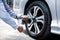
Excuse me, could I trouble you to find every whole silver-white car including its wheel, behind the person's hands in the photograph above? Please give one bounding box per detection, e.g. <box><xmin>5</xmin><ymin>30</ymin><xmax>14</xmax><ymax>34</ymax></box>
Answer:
<box><xmin>8</xmin><ymin>0</ymin><xmax>60</xmax><ymax>39</ymax></box>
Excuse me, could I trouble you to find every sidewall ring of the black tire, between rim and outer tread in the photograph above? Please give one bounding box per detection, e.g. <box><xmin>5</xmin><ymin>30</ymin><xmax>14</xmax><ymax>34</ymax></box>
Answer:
<box><xmin>26</xmin><ymin>1</ymin><xmax>50</xmax><ymax>39</ymax></box>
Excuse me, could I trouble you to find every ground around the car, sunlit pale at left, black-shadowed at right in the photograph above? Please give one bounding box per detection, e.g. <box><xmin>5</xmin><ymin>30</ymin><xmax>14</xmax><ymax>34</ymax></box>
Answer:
<box><xmin>0</xmin><ymin>20</ymin><xmax>60</xmax><ymax>40</ymax></box>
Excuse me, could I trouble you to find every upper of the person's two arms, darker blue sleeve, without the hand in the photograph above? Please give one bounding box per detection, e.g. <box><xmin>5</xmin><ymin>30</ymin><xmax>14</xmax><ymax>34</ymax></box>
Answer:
<box><xmin>2</xmin><ymin>0</ymin><xmax>20</xmax><ymax>19</ymax></box>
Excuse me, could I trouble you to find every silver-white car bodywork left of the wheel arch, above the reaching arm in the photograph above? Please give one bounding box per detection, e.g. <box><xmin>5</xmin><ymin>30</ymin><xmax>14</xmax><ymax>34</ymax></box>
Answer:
<box><xmin>13</xmin><ymin>0</ymin><xmax>28</xmax><ymax>15</ymax></box>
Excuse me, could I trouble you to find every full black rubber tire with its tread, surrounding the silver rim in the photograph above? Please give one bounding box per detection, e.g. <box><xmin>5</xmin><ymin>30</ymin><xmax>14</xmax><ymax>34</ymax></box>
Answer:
<box><xmin>25</xmin><ymin>1</ymin><xmax>51</xmax><ymax>39</ymax></box>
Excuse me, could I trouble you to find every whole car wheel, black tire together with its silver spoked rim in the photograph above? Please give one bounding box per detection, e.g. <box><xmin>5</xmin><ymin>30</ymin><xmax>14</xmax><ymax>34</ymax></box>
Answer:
<box><xmin>25</xmin><ymin>1</ymin><xmax>51</xmax><ymax>39</ymax></box>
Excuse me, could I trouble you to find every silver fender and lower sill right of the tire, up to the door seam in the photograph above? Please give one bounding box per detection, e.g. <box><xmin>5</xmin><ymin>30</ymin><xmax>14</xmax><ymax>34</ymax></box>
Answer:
<box><xmin>46</xmin><ymin>0</ymin><xmax>60</xmax><ymax>34</ymax></box>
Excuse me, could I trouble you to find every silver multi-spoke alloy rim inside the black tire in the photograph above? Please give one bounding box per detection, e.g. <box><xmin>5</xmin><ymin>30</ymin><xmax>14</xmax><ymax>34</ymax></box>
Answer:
<box><xmin>27</xmin><ymin>6</ymin><xmax>44</xmax><ymax>35</ymax></box>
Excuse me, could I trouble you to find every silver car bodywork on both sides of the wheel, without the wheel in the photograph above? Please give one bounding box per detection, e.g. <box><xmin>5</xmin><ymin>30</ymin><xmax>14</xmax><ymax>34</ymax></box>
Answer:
<box><xmin>13</xmin><ymin>0</ymin><xmax>60</xmax><ymax>34</ymax></box>
